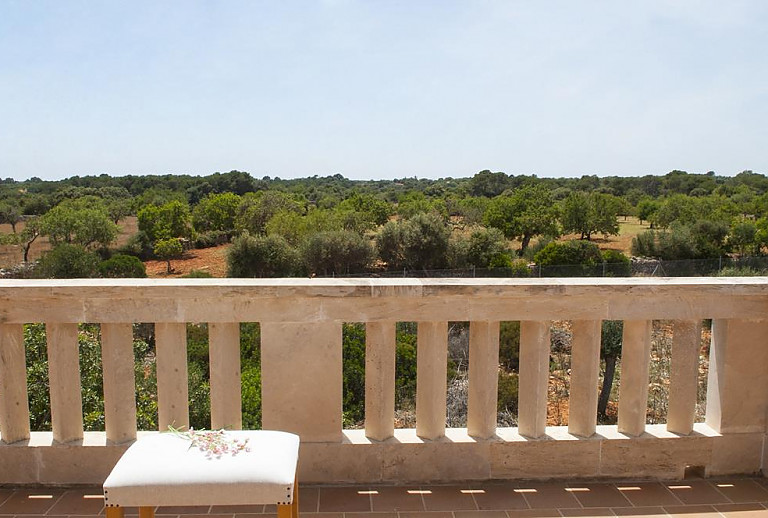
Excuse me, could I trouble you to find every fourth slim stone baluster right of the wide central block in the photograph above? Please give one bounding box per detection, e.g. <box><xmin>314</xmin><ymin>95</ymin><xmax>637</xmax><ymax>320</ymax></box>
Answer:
<box><xmin>517</xmin><ymin>321</ymin><xmax>550</xmax><ymax>438</ymax></box>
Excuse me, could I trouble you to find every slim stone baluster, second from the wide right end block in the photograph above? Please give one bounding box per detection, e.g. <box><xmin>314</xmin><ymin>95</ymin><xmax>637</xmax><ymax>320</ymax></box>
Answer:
<box><xmin>618</xmin><ymin>320</ymin><xmax>652</xmax><ymax>436</ymax></box>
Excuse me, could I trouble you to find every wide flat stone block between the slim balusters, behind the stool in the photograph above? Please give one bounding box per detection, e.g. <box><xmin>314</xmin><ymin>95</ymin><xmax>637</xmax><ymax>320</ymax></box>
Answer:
<box><xmin>261</xmin><ymin>322</ymin><xmax>342</xmax><ymax>442</ymax></box>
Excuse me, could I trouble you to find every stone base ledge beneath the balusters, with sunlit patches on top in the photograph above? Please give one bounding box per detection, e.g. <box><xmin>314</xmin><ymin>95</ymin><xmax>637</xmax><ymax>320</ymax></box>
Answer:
<box><xmin>0</xmin><ymin>423</ymin><xmax>766</xmax><ymax>486</ymax></box>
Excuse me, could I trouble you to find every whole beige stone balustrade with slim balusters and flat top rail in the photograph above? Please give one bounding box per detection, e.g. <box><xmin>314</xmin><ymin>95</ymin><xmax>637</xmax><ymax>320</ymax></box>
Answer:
<box><xmin>0</xmin><ymin>278</ymin><xmax>768</xmax><ymax>484</ymax></box>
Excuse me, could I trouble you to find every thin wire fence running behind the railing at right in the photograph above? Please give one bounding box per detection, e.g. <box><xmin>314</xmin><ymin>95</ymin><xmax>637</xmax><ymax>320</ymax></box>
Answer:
<box><xmin>324</xmin><ymin>256</ymin><xmax>768</xmax><ymax>278</ymax></box>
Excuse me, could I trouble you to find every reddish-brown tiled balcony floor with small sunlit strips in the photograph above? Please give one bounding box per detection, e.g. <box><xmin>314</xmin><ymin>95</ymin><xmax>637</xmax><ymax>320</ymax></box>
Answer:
<box><xmin>0</xmin><ymin>478</ymin><xmax>768</xmax><ymax>518</ymax></box>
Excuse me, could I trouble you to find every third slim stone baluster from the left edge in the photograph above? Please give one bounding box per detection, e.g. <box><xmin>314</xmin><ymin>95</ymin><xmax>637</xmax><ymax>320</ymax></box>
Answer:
<box><xmin>101</xmin><ymin>324</ymin><xmax>136</xmax><ymax>444</ymax></box>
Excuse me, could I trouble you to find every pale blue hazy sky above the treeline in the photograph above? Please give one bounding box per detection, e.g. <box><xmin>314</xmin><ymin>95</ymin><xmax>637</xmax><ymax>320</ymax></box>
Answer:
<box><xmin>0</xmin><ymin>0</ymin><xmax>768</xmax><ymax>180</ymax></box>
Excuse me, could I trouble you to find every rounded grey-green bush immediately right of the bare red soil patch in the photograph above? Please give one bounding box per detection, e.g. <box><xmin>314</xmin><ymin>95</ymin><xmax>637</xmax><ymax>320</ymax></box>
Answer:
<box><xmin>227</xmin><ymin>233</ymin><xmax>299</xmax><ymax>277</ymax></box>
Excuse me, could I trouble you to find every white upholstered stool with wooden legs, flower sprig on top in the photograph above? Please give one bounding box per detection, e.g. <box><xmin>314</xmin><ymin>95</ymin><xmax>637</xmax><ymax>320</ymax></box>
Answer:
<box><xmin>104</xmin><ymin>430</ymin><xmax>299</xmax><ymax>518</ymax></box>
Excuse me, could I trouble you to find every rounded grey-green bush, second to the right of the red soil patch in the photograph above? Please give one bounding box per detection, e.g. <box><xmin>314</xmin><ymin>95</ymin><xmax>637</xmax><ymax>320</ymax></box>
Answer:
<box><xmin>301</xmin><ymin>230</ymin><xmax>373</xmax><ymax>275</ymax></box>
